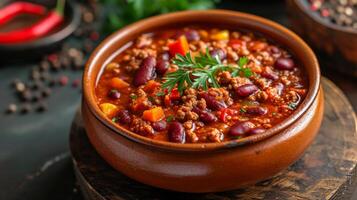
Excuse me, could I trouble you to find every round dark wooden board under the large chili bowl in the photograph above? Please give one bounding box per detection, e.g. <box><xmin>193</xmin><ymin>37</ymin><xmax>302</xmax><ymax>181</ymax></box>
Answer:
<box><xmin>70</xmin><ymin>79</ymin><xmax>357</xmax><ymax>200</ymax></box>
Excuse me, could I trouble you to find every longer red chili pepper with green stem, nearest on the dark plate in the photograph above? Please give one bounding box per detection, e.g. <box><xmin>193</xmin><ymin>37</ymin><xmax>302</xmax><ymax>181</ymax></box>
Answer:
<box><xmin>0</xmin><ymin>0</ymin><xmax>64</xmax><ymax>44</ymax></box>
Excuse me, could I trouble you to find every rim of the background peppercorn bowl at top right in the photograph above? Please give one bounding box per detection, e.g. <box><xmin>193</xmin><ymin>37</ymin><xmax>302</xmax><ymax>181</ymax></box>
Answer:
<box><xmin>290</xmin><ymin>0</ymin><xmax>357</xmax><ymax>34</ymax></box>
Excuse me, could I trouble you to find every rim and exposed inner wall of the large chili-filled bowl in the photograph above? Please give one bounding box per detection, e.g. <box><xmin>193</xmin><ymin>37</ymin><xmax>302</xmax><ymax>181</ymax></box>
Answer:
<box><xmin>83</xmin><ymin>10</ymin><xmax>320</xmax><ymax>151</ymax></box>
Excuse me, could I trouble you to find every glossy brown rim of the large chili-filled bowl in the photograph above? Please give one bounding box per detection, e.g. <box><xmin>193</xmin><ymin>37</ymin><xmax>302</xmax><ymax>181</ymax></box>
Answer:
<box><xmin>82</xmin><ymin>10</ymin><xmax>320</xmax><ymax>151</ymax></box>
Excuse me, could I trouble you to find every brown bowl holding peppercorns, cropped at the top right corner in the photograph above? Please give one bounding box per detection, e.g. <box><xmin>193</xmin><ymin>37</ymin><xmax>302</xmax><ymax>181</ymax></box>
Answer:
<box><xmin>286</xmin><ymin>0</ymin><xmax>357</xmax><ymax>77</ymax></box>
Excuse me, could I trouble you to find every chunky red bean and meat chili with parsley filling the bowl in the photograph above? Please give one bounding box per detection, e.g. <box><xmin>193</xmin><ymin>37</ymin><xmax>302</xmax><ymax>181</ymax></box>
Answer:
<box><xmin>95</xmin><ymin>26</ymin><xmax>308</xmax><ymax>143</ymax></box>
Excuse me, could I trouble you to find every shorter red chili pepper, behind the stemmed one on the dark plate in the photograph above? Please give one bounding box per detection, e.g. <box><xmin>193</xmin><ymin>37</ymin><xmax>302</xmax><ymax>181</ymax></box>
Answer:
<box><xmin>0</xmin><ymin>1</ymin><xmax>47</xmax><ymax>25</ymax></box>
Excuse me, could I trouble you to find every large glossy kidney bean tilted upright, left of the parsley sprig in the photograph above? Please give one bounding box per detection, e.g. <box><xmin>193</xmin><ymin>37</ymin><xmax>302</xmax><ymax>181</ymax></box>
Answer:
<box><xmin>133</xmin><ymin>56</ymin><xmax>156</xmax><ymax>87</ymax></box>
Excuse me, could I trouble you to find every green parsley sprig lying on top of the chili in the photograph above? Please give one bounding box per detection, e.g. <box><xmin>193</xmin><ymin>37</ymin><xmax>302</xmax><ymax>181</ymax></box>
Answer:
<box><xmin>162</xmin><ymin>49</ymin><xmax>253</xmax><ymax>95</ymax></box>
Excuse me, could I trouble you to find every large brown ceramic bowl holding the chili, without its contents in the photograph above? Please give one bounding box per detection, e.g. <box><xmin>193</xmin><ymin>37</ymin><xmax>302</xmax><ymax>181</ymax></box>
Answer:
<box><xmin>82</xmin><ymin>10</ymin><xmax>323</xmax><ymax>192</ymax></box>
